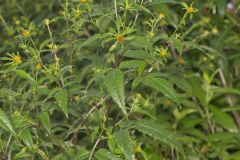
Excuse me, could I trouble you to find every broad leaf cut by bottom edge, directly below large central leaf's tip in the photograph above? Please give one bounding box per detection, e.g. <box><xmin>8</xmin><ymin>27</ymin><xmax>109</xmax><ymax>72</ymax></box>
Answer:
<box><xmin>114</xmin><ymin>130</ymin><xmax>135</xmax><ymax>160</ymax></box>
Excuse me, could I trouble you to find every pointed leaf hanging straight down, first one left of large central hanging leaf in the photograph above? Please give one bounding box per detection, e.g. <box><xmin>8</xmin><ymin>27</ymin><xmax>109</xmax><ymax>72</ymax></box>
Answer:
<box><xmin>55</xmin><ymin>89</ymin><xmax>68</xmax><ymax>117</ymax></box>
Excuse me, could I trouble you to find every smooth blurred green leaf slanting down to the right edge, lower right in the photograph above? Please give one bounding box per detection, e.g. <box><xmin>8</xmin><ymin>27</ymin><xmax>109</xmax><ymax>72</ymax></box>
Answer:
<box><xmin>210</xmin><ymin>106</ymin><xmax>238</xmax><ymax>132</ymax></box>
